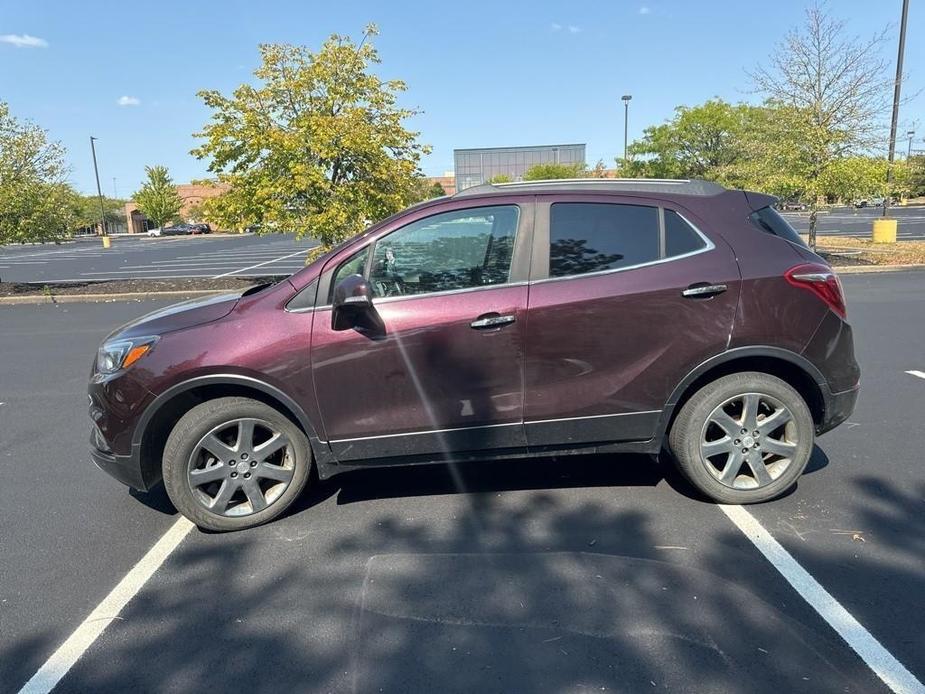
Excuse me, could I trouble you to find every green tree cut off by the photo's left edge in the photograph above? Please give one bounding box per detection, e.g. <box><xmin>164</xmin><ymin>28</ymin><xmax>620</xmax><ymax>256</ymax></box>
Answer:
<box><xmin>0</xmin><ymin>101</ymin><xmax>77</xmax><ymax>245</ymax></box>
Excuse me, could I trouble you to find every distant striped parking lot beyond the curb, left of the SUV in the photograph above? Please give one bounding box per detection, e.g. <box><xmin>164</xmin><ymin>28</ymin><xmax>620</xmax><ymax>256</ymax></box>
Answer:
<box><xmin>0</xmin><ymin>234</ymin><xmax>315</xmax><ymax>283</ymax></box>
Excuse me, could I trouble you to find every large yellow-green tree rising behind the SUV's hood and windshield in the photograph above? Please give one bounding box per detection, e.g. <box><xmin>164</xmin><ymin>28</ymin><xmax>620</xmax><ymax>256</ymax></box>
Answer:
<box><xmin>193</xmin><ymin>24</ymin><xmax>430</xmax><ymax>246</ymax></box>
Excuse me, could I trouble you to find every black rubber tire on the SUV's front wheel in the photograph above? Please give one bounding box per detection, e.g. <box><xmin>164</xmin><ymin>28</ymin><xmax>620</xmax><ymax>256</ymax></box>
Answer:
<box><xmin>162</xmin><ymin>397</ymin><xmax>312</xmax><ymax>532</ymax></box>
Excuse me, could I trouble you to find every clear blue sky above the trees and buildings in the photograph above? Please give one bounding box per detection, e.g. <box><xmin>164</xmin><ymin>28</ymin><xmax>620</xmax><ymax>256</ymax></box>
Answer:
<box><xmin>0</xmin><ymin>0</ymin><xmax>925</xmax><ymax>197</ymax></box>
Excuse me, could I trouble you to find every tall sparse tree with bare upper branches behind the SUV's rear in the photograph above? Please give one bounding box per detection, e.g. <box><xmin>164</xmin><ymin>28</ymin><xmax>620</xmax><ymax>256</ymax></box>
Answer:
<box><xmin>752</xmin><ymin>5</ymin><xmax>892</xmax><ymax>247</ymax></box>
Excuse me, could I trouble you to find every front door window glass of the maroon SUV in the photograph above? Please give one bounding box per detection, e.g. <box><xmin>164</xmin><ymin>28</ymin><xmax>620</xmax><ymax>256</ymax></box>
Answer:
<box><xmin>369</xmin><ymin>205</ymin><xmax>518</xmax><ymax>296</ymax></box>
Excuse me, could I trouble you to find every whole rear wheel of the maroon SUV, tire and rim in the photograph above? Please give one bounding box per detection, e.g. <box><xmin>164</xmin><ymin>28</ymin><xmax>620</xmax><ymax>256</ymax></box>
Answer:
<box><xmin>668</xmin><ymin>372</ymin><xmax>814</xmax><ymax>504</ymax></box>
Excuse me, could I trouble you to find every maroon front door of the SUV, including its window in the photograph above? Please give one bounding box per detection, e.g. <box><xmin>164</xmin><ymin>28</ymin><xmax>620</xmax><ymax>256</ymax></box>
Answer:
<box><xmin>312</xmin><ymin>202</ymin><xmax>533</xmax><ymax>461</ymax></box>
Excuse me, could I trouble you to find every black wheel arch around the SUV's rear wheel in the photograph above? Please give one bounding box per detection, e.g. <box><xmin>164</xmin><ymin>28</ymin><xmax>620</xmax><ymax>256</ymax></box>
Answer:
<box><xmin>656</xmin><ymin>347</ymin><xmax>828</xmax><ymax>441</ymax></box>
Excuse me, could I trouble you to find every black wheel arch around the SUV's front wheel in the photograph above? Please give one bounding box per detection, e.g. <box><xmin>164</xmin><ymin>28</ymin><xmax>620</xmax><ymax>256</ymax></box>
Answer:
<box><xmin>132</xmin><ymin>374</ymin><xmax>331</xmax><ymax>489</ymax></box>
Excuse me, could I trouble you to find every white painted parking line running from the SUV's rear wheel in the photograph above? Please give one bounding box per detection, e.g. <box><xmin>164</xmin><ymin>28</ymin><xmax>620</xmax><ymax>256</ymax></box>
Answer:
<box><xmin>719</xmin><ymin>504</ymin><xmax>925</xmax><ymax>694</ymax></box>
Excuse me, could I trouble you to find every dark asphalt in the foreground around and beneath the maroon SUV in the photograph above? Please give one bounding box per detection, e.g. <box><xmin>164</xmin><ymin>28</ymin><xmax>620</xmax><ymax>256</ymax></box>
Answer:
<box><xmin>0</xmin><ymin>270</ymin><xmax>925</xmax><ymax>693</ymax></box>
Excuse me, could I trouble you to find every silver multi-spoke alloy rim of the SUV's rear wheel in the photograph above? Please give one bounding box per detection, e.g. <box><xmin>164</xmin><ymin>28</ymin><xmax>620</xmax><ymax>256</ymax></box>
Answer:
<box><xmin>700</xmin><ymin>393</ymin><xmax>799</xmax><ymax>489</ymax></box>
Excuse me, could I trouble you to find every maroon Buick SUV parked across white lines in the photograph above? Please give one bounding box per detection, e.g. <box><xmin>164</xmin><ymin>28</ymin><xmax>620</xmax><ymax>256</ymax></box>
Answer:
<box><xmin>90</xmin><ymin>180</ymin><xmax>859</xmax><ymax>530</ymax></box>
